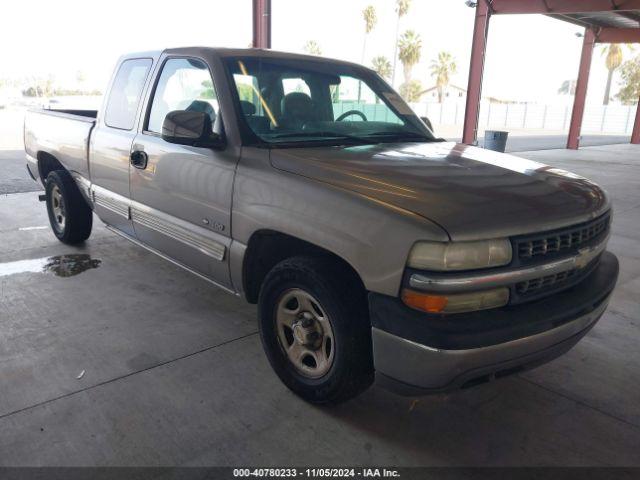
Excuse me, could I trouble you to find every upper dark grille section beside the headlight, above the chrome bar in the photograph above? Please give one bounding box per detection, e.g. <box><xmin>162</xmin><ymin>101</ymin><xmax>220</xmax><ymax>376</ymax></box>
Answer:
<box><xmin>515</xmin><ymin>214</ymin><xmax>610</xmax><ymax>260</ymax></box>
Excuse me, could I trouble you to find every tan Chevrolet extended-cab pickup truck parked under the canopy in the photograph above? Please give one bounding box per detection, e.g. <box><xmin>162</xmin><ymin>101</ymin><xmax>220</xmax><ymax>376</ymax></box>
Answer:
<box><xmin>24</xmin><ymin>48</ymin><xmax>618</xmax><ymax>403</ymax></box>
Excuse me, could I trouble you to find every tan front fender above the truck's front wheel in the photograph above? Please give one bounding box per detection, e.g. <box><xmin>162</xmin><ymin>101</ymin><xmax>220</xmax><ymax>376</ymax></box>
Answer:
<box><xmin>231</xmin><ymin>148</ymin><xmax>449</xmax><ymax>295</ymax></box>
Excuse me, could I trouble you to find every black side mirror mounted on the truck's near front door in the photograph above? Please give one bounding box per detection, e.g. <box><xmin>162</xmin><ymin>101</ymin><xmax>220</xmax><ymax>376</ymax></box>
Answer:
<box><xmin>162</xmin><ymin>110</ymin><xmax>224</xmax><ymax>148</ymax></box>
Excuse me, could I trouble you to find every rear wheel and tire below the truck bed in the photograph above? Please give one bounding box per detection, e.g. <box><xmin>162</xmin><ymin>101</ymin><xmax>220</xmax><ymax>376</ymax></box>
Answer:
<box><xmin>45</xmin><ymin>170</ymin><xmax>93</xmax><ymax>245</ymax></box>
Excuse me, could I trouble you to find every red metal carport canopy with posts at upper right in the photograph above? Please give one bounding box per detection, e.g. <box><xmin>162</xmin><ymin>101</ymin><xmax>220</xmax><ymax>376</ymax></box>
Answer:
<box><xmin>462</xmin><ymin>0</ymin><xmax>640</xmax><ymax>149</ymax></box>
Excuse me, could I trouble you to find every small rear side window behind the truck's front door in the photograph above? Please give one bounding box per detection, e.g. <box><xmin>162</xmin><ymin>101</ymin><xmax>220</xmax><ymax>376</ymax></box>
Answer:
<box><xmin>104</xmin><ymin>58</ymin><xmax>152</xmax><ymax>130</ymax></box>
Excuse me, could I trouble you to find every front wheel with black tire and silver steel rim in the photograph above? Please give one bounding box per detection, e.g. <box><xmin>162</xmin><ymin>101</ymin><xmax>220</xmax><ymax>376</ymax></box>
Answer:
<box><xmin>258</xmin><ymin>257</ymin><xmax>373</xmax><ymax>404</ymax></box>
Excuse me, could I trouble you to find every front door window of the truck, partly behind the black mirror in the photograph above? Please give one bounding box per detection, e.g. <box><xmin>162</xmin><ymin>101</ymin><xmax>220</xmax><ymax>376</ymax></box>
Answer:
<box><xmin>147</xmin><ymin>58</ymin><xmax>218</xmax><ymax>133</ymax></box>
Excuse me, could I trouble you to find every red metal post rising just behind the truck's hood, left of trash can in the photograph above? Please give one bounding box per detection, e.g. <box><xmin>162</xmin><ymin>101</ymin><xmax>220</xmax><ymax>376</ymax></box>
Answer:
<box><xmin>462</xmin><ymin>0</ymin><xmax>491</xmax><ymax>145</ymax></box>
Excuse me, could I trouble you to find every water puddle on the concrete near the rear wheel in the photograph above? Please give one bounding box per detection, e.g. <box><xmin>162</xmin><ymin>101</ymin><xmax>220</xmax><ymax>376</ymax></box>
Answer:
<box><xmin>0</xmin><ymin>253</ymin><xmax>102</xmax><ymax>277</ymax></box>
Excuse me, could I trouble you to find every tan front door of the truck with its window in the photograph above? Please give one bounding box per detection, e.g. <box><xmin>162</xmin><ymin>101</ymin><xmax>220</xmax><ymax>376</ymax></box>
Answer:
<box><xmin>131</xmin><ymin>57</ymin><xmax>237</xmax><ymax>288</ymax></box>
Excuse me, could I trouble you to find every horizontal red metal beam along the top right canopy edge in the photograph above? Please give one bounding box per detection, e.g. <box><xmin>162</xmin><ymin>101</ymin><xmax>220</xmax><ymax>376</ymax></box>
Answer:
<box><xmin>478</xmin><ymin>0</ymin><xmax>640</xmax><ymax>15</ymax></box>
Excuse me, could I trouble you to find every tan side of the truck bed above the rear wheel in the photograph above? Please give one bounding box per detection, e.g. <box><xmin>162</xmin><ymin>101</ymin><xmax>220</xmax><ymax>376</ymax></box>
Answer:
<box><xmin>24</xmin><ymin>109</ymin><xmax>98</xmax><ymax>184</ymax></box>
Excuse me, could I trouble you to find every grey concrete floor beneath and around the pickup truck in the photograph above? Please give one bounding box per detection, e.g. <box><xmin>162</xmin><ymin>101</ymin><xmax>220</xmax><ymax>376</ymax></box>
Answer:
<box><xmin>0</xmin><ymin>145</ymin><xmax>640</xmax><ymax>466</ymax></box>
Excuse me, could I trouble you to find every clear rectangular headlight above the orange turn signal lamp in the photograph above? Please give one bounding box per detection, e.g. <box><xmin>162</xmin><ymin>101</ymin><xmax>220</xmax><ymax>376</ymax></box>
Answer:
<box><xmin>407</xmin><ymin>238</ymin><xmax>511</xmax><ymax>271</ymax></box>
